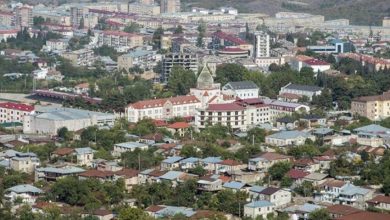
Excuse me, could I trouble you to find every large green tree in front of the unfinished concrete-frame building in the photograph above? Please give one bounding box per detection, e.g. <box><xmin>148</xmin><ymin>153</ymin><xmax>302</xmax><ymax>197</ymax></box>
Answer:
<box><xmin>167</xmin><ymin>66</ymin><xmax>196</xmax><ymax>95</ymax></box>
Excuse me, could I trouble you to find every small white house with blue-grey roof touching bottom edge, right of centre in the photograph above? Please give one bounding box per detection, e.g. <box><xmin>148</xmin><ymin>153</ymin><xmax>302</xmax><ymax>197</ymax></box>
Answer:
<box><xmin>244</xmin><ymin>200</ymin><xmax>275</xmax><ymax>219</ymax></box>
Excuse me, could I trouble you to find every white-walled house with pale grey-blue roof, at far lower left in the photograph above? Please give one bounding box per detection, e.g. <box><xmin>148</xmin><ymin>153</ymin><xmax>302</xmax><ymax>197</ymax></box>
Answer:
<box><xmin>4</xmin><ymin>184</ymin><xmax>43</xmax><ymax>205</ymax></box>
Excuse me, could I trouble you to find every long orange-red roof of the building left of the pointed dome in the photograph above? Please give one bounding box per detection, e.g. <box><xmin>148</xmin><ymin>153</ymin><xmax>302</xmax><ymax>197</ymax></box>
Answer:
<box><xmin>128</xmin><ymin>95</ymin><xmax>200</xmax><ymax>109</ymax></box>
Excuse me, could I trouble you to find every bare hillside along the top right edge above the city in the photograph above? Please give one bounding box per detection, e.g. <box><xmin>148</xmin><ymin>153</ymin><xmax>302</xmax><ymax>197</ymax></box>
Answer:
<box><xmin>182</xmin><ymin>0</ymin><xmax>390</xmax><ymax>25</ymax></box>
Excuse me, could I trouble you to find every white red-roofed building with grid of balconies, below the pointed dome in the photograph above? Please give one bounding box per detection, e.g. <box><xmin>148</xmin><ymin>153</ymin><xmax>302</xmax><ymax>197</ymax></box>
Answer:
<box><xmin>195</xmin><ymin>103</ymin><xmax>247</xmax><ymax>131</ymax></box>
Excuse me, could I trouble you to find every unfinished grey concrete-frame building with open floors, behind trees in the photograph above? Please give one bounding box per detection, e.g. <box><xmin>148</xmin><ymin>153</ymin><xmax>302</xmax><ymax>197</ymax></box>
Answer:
<box><xmin>160</xmin><ymin>53</ymin><xmax>198</xmax><ymax>82</ymax></box>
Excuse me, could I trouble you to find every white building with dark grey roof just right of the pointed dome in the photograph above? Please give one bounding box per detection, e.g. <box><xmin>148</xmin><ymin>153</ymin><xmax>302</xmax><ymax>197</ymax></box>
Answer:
<box><xmin>222</xmin><ymin>81</ymin><xmax>260</xmax><ymax>99</ymax></box>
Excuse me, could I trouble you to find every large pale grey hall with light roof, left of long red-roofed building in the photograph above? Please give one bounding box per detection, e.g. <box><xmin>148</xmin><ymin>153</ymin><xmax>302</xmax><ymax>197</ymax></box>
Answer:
<box><xmin>23</xmin><ymin>107</ymin><xmax>115</xmax><ymax>135</ymax></box>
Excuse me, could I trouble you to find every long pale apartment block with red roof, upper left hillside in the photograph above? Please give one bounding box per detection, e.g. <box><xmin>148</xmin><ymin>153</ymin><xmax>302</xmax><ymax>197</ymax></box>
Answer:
<box><xmin>97</xmin><ymin>31</ymin><xmax>144</xmax><ymax>49</ymax></box>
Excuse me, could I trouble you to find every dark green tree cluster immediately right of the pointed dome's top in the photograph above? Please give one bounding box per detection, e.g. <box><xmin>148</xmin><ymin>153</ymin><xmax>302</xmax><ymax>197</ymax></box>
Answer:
<box><xmin>215</xmin><ymin>63</ymin><xmax>248</xmax><ymax>85</ymax></box>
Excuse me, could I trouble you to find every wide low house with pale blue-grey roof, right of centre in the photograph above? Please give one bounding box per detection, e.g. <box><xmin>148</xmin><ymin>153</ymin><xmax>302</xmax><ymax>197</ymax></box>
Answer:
<box><xmin>265</xmin><ymin>131</ymin><xmax>315</xmax><ymax>147</ymax></box>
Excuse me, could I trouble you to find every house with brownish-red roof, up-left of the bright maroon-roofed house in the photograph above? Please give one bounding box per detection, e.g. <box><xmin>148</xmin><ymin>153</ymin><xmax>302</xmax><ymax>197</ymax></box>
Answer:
<box><xmin>248</xmin><ymin>152</ymin><xmax>292</xmax><ymax>172</ymax></box>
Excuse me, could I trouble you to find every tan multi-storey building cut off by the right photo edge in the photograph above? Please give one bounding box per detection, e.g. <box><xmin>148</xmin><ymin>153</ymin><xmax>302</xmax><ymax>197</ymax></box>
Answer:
<box><xmin>351</xmin><ymin>91</ymin><xmax>390</xmax><ymax>120</ymax></box>
